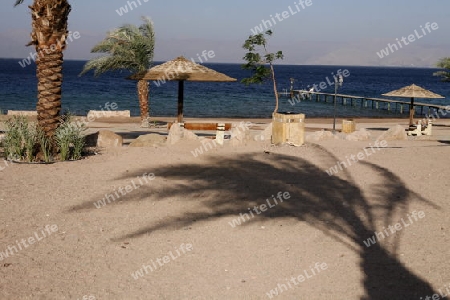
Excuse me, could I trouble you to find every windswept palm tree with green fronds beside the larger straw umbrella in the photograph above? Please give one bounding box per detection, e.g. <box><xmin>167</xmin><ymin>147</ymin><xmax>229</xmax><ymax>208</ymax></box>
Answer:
<box><xmin>80</xmin><ymin>17</ymin><xmax>155</xmax><ymax>127</ymax></box>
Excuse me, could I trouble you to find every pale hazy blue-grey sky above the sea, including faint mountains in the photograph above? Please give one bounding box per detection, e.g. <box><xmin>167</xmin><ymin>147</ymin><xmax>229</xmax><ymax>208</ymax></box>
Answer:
<box><xmin>0</xmin><ymin>0</ymin><xmax>450</xmax><ymax>66</ymax></box>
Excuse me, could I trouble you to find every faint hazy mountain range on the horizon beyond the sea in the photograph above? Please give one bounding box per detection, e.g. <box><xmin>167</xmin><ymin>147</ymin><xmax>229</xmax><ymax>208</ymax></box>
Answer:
<box><xmin>0</xmin><ymin>30</ymin><xmax>450</xmax><ymax>67</ymax></box>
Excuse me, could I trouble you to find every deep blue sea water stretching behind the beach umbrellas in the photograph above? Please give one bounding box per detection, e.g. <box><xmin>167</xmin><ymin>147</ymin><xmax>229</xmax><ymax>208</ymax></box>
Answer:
<box><xmin>0</xmin><ymin>59</ymin><xmax>450</xmax><ymax>118</ymax></box>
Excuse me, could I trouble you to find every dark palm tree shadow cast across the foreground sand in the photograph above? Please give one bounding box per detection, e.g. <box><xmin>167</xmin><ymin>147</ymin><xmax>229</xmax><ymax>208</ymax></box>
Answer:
<box><xmin>74</xmin><ymin>147</ymin><xmax>438</xmax><ymax>300</ymax></box>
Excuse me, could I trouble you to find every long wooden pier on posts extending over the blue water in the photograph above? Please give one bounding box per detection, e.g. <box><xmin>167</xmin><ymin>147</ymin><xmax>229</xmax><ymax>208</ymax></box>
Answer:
<box><xmin>280</xmin><ymin>90</ymin><xmax>446</xmax><ymax>116</ymax></box>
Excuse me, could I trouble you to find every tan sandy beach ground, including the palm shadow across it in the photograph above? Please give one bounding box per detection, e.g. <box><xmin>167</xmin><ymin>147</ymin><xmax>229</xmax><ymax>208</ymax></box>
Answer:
<box><xmin>0</xmin><ymin>118</ymin><xmax>450</xmax><ymax>300</ymax></box>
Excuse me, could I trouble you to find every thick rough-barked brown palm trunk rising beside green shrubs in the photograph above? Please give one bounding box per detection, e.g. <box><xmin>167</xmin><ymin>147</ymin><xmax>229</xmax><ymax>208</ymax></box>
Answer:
<box><xmin>15</xmin><ymin>0</ymin><xmax>71</xmax><ymax>144</ymax></box>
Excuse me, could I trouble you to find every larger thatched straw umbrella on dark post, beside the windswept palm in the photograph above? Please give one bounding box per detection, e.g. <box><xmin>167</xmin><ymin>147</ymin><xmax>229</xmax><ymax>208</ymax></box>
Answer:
<box><xmin>129</xmin><ymin>56</ymin><xmax>237</xmax><ymax>123</ymax></box>
